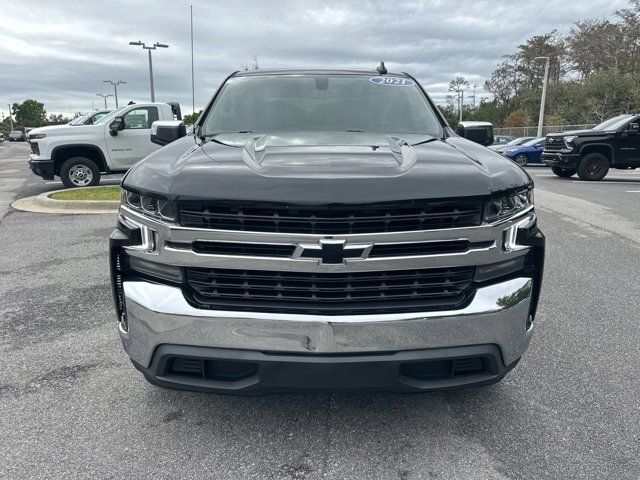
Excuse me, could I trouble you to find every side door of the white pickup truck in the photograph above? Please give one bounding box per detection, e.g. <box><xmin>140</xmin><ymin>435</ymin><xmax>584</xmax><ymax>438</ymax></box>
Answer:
<box><xmin>106</xmin><ymin>107</ymin><xmax>160</xmax><ymax>170</ymax></box>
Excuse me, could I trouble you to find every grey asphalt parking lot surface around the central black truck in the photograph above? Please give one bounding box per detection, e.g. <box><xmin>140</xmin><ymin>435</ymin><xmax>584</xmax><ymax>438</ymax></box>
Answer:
<box><xmin>0</xmin><ymin>143</ymin><xmax>640</xmax><ymax>479</ymax></box>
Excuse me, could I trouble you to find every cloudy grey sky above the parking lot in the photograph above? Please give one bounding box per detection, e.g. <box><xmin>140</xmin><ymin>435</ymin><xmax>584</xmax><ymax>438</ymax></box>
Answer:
<box><xmin>0</xmin><ymin>0</ymin><xmax>627</xmax><ymax>115</ymax></box>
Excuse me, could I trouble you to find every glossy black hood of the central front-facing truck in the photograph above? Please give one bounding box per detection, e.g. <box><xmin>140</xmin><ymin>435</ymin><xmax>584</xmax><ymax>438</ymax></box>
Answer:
<box><xmin>124</xmin><ymin>132</ymin><xmax>532</xmax><ymax>204</ymax></box>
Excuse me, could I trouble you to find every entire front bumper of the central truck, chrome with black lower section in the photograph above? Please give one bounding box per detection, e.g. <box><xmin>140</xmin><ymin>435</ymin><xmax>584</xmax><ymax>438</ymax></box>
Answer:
<box><xmin>120</xmin><ymin>277</ymin><xmax>533</xmax><ymax>394</ymax></box>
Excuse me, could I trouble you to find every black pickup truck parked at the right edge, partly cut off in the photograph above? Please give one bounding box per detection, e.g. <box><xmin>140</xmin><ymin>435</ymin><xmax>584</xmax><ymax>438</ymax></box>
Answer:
<box><xmin>542</xmin><ymin>114</ymin><xmax>640</xmax><ymax>180</ymax></box>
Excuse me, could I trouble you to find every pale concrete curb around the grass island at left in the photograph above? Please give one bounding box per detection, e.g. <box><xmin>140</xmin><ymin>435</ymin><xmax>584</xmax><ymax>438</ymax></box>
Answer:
<box><xmin>11</xmin><ymin>187</ymin><xmax>120</xmax><ymax>214</ymax></box>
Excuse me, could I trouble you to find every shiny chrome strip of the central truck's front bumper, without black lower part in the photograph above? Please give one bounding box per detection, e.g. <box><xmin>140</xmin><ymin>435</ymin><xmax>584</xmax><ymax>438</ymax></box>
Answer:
<box><xmin>120</xmin><ymin>278</ymin><xmax>533</xmax><ymax>367</ymax></box>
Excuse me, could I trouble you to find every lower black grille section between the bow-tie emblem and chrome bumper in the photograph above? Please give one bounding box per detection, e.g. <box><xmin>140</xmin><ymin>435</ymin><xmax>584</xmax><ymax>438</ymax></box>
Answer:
<box><xmin>186</xmin><ymin>267</ymin><xmax>474</xmax><ymax>315</ymax></box>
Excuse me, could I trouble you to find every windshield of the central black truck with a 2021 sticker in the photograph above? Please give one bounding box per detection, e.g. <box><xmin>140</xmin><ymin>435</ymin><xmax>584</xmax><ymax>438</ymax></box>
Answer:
<box><xmin>202</xmin><ymin>74</ymin><xmax>441</xmax><ymax>138</ymax></box>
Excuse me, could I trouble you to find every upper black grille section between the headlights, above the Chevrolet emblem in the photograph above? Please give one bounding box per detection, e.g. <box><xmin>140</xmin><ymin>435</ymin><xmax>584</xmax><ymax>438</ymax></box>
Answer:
<box><xmin>179</xmin><ymin>200</ymin><xmax>483</xmax><ymax>234</ymax></box>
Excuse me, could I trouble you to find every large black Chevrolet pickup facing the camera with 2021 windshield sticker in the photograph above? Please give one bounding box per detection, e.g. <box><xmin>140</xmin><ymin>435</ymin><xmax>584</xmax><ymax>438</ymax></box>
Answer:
<box><xmin>110</xmin><ymin>66</ymin><xmax>544</xmax><ymax>395</ymax></box>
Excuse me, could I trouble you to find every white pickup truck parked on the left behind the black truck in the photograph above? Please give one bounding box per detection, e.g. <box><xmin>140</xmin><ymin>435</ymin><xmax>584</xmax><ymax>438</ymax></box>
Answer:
<box><xmin>28</xmin><ymin>102</ymin><xmax>181</xmax><ymax>188</ymax></box>
